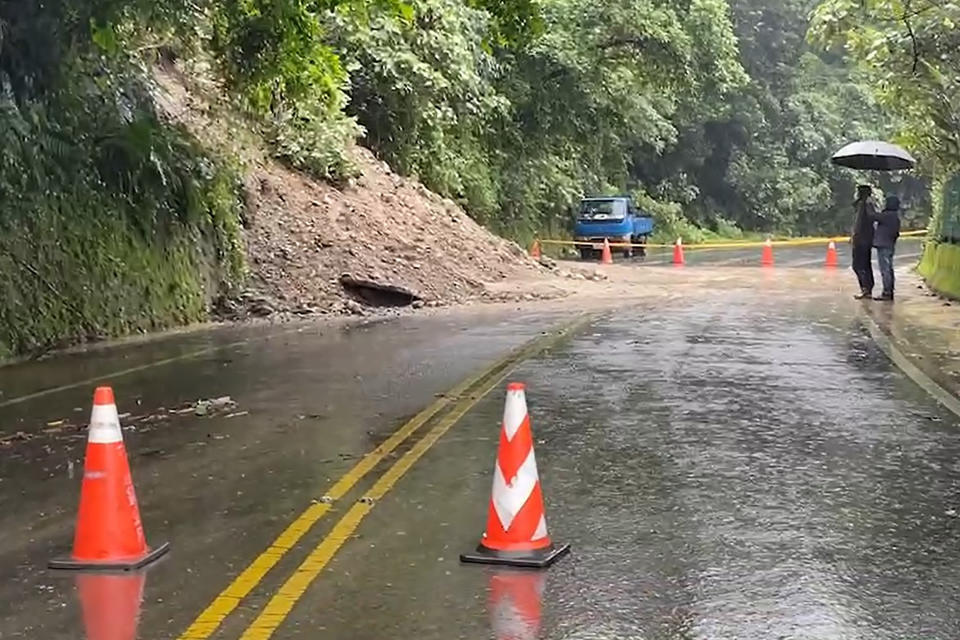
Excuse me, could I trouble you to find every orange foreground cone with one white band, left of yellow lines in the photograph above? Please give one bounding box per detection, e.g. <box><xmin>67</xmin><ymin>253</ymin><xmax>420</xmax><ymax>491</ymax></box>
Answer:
<box><xmin>49</xmin><ymin>387</ymin><xmax>170</xmax><ymax>571</ymax></box>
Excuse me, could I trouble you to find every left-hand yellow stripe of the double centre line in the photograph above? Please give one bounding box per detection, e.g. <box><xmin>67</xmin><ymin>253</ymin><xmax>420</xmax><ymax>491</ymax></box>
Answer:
<box><xmin>178</xmin><ymin>317</ymin><xmax>586</xmax><ymax>640</ymax></box>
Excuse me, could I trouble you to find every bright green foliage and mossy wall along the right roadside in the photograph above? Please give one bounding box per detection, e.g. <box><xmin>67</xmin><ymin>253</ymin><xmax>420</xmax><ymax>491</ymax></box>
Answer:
<box><xmin>810</xmin><ymin>0</ymin><xmax>960</xmax><ymax>297</ymax></box>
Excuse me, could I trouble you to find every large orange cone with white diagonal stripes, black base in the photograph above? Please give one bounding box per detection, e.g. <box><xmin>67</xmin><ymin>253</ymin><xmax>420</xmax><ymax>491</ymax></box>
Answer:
<box><xmin>460</xmin><ymin>383</ymin><xmax>570</xmax><ymax>568</ymax></box>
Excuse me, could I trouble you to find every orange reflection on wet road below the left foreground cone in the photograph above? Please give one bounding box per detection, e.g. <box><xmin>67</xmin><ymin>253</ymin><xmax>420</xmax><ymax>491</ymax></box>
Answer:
<box><xmin>77</xmin><ymin>572</ymin><xmax>146</xmax><ymax>640</ymax></box>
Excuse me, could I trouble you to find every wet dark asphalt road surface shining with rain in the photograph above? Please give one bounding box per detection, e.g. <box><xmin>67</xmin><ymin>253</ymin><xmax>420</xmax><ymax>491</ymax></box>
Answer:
<box><xmin>0</xmin><ymin>240</ymin><xmax>960</xmax><ymax>640</ymax></box>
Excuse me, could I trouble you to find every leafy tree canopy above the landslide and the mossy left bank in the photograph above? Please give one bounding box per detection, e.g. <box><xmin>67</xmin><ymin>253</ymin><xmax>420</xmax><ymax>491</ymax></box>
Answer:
<box><xmin>0</xmin><ymin>0</ymin><xmax>940</xmax><ymax>244</ymax></box>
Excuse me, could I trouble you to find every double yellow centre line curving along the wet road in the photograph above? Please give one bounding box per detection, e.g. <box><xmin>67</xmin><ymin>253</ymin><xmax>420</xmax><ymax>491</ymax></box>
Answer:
<box><xmin>178</xmin><ymin>315</ymin><xmax>589</xmax><ymax>640</ymax></box>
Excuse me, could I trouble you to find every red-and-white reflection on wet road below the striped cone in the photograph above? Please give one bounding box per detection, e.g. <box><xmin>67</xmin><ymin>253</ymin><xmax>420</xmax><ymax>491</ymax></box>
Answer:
<box><xmin>488</xmin><ymin>569</ymin><xmax>546</xmax><ymax>640</ymax></box>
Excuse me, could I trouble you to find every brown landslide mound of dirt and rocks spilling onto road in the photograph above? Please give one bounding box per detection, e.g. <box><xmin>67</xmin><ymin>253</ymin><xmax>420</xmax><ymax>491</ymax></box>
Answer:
<box><xmin>154</xmin><ymin>65</ymin><xmax>561</xmax><ymax>318</ymax></box>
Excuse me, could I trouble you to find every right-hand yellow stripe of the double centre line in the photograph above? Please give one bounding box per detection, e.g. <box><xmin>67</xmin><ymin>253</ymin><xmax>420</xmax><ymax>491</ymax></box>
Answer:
<box><xmin>240</xmin><ymin>360</ymin><xmax>510</xmax><ymax>640</ymax></box>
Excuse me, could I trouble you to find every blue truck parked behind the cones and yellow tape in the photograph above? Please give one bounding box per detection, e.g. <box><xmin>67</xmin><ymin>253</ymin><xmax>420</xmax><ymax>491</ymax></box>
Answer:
<box><xmin>573</xmin><ymin>196</ymin><xmax>653</xmax><ymax>260</ymax></box>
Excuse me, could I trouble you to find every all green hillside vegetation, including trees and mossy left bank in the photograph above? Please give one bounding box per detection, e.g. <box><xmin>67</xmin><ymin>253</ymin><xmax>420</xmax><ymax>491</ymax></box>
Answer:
<box><xmin>0</xmin><ymin>0</ymin><xmax>960</xmax><ymax>357</ymax></box>
